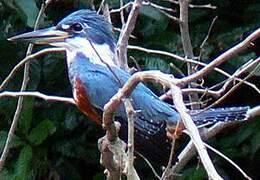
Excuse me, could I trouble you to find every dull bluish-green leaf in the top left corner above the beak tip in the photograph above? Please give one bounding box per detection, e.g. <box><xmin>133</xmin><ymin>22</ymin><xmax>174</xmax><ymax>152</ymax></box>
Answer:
<box><xmin>15</xmin><ymin>0</ymin><xmax>39</xmax><ymax>27</ymax></box>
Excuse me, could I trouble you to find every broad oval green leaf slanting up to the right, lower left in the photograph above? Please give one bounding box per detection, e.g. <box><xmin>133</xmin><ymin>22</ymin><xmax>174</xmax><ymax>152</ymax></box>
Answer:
<box><xmin>28</xmin><ymin>119</ymin><xmax>56</xmax><ymax>145</ymax></box>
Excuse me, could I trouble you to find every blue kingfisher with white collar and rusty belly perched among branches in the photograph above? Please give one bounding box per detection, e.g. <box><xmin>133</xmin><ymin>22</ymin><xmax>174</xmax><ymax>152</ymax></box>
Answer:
<box><xmin>9</xmin><ymin>10</ymin><xmax>253</xmax><ymax>164</ymax></box>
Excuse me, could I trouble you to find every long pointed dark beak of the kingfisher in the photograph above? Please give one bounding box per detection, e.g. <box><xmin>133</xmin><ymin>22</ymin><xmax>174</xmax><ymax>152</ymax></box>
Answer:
<box><xmin>8</xmin><ymin>27</ymin><xmax>70</xmax><ymax>44</ymax></box>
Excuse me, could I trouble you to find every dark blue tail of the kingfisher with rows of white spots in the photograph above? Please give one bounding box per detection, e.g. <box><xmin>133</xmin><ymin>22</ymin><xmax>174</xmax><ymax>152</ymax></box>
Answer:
<box><xmin>190</xmin><ymin>106</ymin><xmax>250</xmax><ymax>125</ymax></box>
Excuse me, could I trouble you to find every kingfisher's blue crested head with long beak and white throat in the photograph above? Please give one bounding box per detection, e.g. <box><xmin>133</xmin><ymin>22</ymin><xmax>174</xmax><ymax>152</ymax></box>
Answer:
<box><xmin>8</xmin><ymin>10</ymin><xmax>115</xmax><ymax>65</ymax></box>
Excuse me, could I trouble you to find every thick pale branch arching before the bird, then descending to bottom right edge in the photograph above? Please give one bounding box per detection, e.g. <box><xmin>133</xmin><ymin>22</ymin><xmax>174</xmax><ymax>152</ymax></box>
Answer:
<box><xmin>103</xmin><ymin>71</ymin><xmax>222</xmax><ymax>179</ymax></box>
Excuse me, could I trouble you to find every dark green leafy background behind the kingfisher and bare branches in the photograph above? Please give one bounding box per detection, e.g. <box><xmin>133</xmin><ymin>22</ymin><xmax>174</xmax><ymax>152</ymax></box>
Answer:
<box><xmin>0</xmin><ymin>0</ymin><xmax>260</xmax><ymax>180</ymax></box>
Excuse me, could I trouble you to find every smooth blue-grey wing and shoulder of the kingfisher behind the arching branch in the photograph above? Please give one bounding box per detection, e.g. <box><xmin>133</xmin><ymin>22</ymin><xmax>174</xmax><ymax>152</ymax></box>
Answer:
<box><xmin>75</xmin><ymin>60</ymin><xmax>179</xmax><ymax>124</ymax></box>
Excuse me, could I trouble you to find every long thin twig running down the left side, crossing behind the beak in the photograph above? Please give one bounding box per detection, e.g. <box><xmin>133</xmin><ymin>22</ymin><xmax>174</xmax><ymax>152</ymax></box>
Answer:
<box><xmin>0</xmin><ymin>0</ymin><xmax>51</xmax><ymax>172</ymax></box>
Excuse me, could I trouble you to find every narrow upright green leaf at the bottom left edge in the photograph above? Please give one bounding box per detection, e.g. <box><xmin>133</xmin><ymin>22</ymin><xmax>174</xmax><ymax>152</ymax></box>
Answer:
<box><xmin>14</xmin><ymin>146</ymin><xmax>33</xmax><ymax>180</ymax></box>
